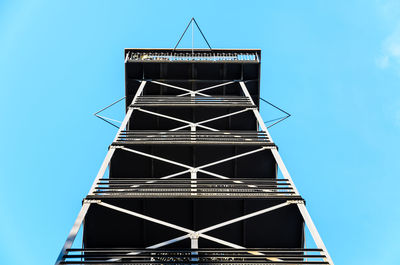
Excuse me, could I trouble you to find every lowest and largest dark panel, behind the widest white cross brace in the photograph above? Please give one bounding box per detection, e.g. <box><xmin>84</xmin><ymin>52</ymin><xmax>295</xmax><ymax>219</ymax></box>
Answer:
<box><xmin>84</xmin><ymin>199</ymin><xmax>303</xmax><ymax>248</ymax></box>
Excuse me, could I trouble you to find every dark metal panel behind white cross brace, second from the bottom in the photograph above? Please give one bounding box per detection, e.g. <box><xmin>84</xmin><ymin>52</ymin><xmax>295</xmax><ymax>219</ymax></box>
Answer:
<box><xmin>110</xmin><ymin>145</ymin><xmax>276</xmax><ymax>178</ymax></box>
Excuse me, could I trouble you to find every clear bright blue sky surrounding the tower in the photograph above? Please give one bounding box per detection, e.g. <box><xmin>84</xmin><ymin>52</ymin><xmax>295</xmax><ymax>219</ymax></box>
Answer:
<box><xmin>0</xmin><ymin>0</ymin><xmax>400</xmax><ymax>265</ymax></box>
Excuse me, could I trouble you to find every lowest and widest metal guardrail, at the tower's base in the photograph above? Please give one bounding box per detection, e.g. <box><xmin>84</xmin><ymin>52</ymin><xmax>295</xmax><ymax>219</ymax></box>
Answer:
<box><xmin>60</xmin><ymin>248</ymin><xmax>329</xmax><ymax>265</ymax></box>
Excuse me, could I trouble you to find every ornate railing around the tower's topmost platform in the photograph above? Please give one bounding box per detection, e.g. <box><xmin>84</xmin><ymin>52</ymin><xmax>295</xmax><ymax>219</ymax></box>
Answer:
<box><xmin>125</xmin><ymin>51</ymin><xmax>259</xmax><ymax>62</ymax></box>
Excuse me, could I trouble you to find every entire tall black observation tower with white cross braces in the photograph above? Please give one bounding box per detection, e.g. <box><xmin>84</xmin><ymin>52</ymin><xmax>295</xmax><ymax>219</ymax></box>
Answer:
<box><xmin>56</xmin><ymin>49</ymin><xmax>333</xmax><ymax>264</ymax></box>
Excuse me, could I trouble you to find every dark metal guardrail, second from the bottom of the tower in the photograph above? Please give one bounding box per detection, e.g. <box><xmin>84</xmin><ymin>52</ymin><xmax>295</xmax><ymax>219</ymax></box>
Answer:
<box><xmin>88</xmin><ymin>178</ymin><xmax>301</xmax><ymax>199</ymax></box>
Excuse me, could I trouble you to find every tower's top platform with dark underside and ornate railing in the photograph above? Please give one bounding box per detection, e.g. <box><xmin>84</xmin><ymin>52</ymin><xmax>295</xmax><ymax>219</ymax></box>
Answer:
<box><xmin>124</xmin><ymin>48</ymin><xmax>261</xmax><ymax>106</ymax></box>
